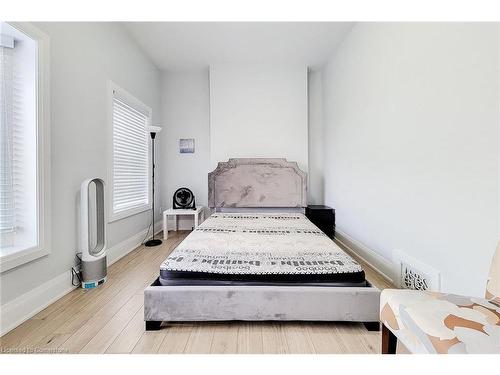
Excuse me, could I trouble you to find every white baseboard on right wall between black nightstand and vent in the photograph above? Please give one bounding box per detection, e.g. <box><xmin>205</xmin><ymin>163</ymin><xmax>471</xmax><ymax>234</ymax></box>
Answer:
<box><xmin>335</xmin><ymin>228</ymin><xmax>394</xmax><ymax>283</ymax></box>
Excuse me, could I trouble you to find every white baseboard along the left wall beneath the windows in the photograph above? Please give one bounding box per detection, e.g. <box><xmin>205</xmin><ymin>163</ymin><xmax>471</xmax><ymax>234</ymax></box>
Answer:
<box><xmin>0</xmin><ymin>221</ymin><xmax>162</xmax><ymax>336</ymax></box>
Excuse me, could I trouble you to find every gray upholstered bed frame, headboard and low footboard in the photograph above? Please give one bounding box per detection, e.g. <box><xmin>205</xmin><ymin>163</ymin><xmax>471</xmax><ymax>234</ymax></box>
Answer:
<box><xmin>144</xmin><ymin>158</ymin><xmax>380</xmax><ymax>330</ymax></box>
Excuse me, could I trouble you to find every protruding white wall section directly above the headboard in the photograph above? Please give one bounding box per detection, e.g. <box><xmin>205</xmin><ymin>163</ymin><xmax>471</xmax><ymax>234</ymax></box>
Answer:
<box><xmin>210</xmin><ymin>64</ymin><xmax>308</xmax><ymax>171</ymax></box>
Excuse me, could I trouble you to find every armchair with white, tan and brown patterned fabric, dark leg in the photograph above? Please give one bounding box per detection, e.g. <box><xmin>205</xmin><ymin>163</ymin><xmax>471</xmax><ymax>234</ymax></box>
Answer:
<box><xmin>380</xmin><ymin>243</ymin><xmax>500</xmax><ymax>354</ymax></box>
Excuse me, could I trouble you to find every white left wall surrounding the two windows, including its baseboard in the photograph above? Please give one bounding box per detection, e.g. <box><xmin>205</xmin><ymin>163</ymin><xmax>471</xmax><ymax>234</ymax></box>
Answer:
<box><xmin>0</xmin><ymin>23</ymin><xmax>161</xmax><ymax>305</ymax></box>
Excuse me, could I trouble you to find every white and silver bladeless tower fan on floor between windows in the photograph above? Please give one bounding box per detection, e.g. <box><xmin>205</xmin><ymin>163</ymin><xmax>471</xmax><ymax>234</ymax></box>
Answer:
<box><xmin>80</xmin><ymin>178</ymin><xmax>107</xmax><ymax>289</ymax></box>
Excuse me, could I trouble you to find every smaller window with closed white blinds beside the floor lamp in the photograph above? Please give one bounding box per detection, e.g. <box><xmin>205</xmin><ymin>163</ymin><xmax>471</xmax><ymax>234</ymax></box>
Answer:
<box><xmin>109</xmin><ymin>83</ymin><xmax>151</xmax><ymax>221</ymax></box>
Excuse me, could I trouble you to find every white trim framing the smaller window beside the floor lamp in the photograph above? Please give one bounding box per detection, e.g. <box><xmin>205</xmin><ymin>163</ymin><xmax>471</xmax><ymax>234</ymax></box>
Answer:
<box><xmin>107</xmin><ymin>80</ymin><xmax>153</xmax><ymax>223</ymax></box>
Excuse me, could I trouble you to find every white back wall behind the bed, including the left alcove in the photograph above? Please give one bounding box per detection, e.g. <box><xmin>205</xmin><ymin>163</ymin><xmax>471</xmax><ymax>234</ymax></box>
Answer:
<box><xmin>159</xmin><ymin>65</ymin><xmax>308</xmax><ymax>229</ymax></box>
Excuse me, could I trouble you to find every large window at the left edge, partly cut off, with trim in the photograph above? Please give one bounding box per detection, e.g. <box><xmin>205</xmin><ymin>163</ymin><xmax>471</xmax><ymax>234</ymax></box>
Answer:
<box><xmin>0</xmin><ymin>22</ymin><xmax>50</xmax><ymax>272</ymax></box>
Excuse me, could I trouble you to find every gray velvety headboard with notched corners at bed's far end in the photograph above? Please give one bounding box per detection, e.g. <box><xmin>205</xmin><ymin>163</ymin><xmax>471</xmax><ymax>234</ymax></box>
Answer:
<box><xmin>208</xmin><ymin>158</ymin><xmax>307</xmax><ymax>208</ymax></box>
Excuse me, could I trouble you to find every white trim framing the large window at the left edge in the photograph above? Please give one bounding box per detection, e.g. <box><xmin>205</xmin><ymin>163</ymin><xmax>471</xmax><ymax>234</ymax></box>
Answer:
<box><xmin>0</xmin><ymin>22</ymin><xmax>52</xmax><ymax>273</ymax></box>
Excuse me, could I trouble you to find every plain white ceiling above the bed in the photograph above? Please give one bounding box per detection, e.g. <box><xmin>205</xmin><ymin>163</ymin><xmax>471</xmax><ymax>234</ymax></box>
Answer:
<box><xmin>125</xmin><ymin>22</ymin><xmax>353</xmax><ymax>71</ymax></box>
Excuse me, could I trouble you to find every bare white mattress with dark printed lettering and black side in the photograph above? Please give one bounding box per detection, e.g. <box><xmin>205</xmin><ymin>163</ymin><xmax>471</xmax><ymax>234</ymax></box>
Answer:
<box><xmin>160</xmin><ymin>213</ymin><xmax>365</xmax><ymax>286</ymax></box>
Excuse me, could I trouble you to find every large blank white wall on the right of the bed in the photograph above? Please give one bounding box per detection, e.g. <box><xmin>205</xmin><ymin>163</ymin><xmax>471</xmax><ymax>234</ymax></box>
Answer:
<box><xmin>323</xmin><ymin>23</ymin><xmax>500</xmax><ymax>296</ymax></box>
